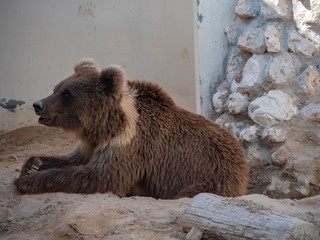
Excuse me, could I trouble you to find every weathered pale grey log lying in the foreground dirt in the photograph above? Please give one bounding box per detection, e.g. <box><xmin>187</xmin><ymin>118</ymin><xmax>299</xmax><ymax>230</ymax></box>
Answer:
<box><xmin>183</xmin><ymin>193</ymin><xmax>320</xmax><ymax>240</ymax></box>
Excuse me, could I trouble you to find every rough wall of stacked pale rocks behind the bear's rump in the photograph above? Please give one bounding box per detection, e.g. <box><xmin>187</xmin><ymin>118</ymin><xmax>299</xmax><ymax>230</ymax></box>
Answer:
<box><xmin>212</xmin><ymin>0</ymin><xmax>320</xmax><ymax>198</ymax></box>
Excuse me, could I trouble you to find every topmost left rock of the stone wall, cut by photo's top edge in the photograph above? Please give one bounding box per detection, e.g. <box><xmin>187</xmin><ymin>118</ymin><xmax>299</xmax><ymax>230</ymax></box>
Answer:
<box><xmin>235</xmin><ymin>0</ymin><xmax>260</xmax><ymax>18</ymax></box>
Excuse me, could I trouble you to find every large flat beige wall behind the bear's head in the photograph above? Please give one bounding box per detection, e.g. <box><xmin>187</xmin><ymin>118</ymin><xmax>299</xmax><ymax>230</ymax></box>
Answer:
<box><xmin>0</xmin><ymin>0</ymin><xmax>196</xmax><ymax>129</ymax></box>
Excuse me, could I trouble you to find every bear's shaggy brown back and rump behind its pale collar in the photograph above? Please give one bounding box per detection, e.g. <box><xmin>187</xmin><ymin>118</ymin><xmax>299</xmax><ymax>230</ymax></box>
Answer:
<box><xmin>128</xmin><ymin>81</ymin><xmax>247</xmax><ymax>198</ymax></box>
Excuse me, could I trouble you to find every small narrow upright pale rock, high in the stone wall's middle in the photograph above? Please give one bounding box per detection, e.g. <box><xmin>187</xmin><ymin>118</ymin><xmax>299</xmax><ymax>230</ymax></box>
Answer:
<box><xmin>264</xmin><ymin>24</ymin><xmax>283</xmax><ymax>53</ymax></box>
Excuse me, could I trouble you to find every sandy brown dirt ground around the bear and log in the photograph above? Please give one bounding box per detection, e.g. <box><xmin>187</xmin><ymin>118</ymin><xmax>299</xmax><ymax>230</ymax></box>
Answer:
<box><xmin>0</xmin><ymin>126</ymin><xmax>320</xmax><ymax>240</ymax></box>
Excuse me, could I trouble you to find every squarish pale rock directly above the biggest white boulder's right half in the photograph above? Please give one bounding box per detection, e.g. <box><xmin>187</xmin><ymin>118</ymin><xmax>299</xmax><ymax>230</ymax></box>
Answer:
<box><xmin>266</xmin><ymin>52</ymin><xmax>296</xmax><ymax>89</ymax></box>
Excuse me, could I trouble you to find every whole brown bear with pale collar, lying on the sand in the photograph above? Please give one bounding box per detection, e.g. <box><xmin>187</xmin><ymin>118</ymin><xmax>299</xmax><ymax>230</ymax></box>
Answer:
<box><xmin>14</xmin><ymin>59</ymin><xmax>248</xmax><ymax>199</ymax></box>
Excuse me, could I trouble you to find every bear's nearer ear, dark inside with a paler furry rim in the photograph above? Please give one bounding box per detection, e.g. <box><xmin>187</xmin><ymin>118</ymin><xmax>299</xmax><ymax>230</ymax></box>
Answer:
<box><xmin>101</xmin><ymin>65</ymin><xmax>125</xmax><ymax>96</ymax></box>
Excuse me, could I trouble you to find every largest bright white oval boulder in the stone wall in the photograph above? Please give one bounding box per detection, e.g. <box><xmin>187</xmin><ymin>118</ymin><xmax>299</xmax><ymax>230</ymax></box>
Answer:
<box><xmin>248</xmin><ymin>90</ymin><xmax>298</xmax><ymax>126</ymax></box>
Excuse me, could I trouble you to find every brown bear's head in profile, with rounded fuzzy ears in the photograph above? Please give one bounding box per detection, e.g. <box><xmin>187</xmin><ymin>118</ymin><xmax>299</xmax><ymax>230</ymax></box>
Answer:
<box><xmin>33</xmin><ymin>59</ymin><xmax>136</xmax><ymax>145</ymax></box>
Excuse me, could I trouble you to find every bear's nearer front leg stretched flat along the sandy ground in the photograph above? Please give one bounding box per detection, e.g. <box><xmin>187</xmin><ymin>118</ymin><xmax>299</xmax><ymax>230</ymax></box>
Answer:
<box><xmin>14</xmin><ymin>166</ymin><xmax>99</xmax><ymax>194</ymax></box>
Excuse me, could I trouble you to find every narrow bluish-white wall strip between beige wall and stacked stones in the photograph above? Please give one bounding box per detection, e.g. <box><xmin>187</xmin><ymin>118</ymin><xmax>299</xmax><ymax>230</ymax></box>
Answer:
<box><xmin>196</xmin><ymin>0</ymin><xmax>237</xmax><ymax>119</ymax></box>
